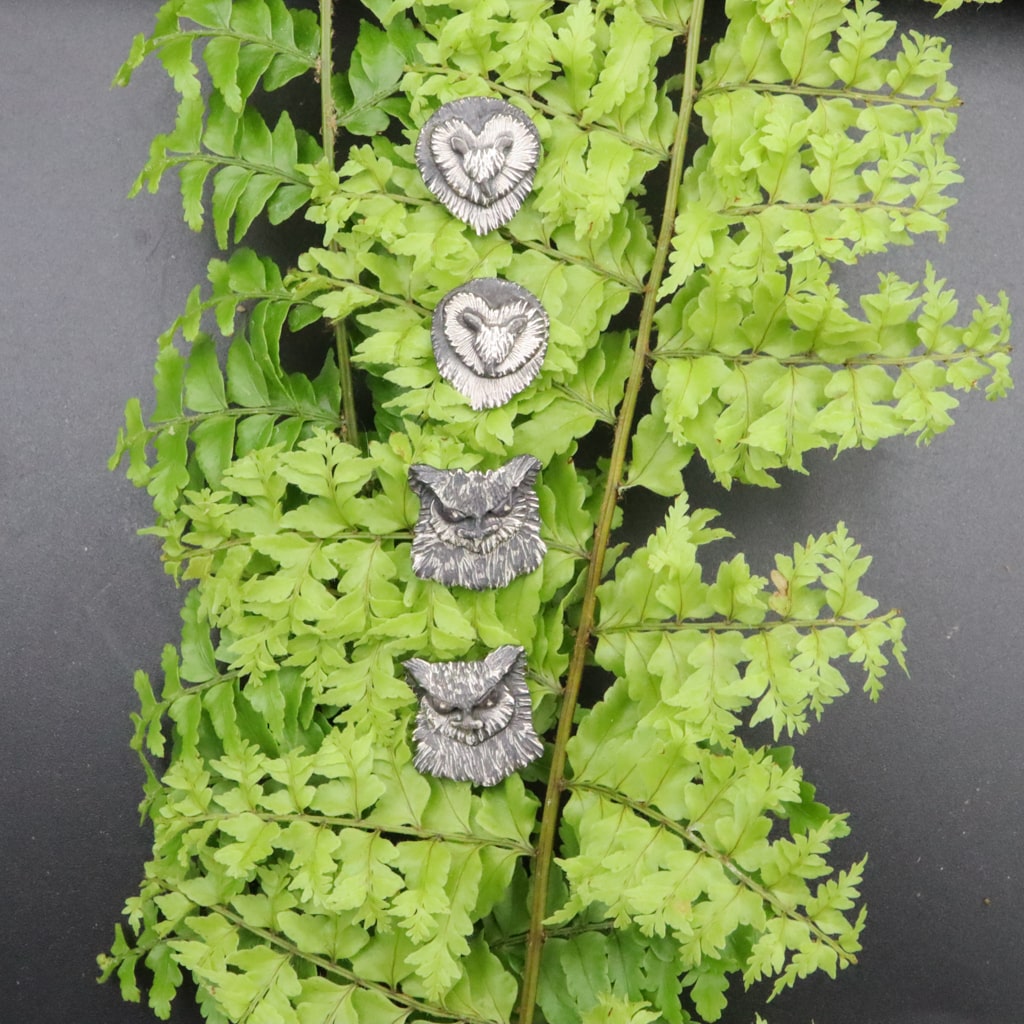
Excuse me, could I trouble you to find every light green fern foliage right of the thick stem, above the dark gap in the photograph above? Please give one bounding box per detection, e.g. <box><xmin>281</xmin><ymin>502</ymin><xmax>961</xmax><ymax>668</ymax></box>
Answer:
<box><xmin>653</xmin><ymin>0</ymin><xmax>1010</xmax><ymax>486</ymax></box>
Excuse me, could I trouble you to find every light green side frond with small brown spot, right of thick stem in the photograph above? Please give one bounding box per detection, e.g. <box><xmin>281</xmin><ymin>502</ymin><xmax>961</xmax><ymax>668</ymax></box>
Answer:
<box><xmin>591</xmin><ymin>507</ymin><xmax>903</xmax><ymax>743</ymax></box>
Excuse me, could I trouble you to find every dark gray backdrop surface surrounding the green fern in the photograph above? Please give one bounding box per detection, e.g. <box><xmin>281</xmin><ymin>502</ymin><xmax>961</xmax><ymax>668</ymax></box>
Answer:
<box><xmin>0</xmin><ymin>0</ymin><xmax>1024</xmax><ymax>1024</ymax></box>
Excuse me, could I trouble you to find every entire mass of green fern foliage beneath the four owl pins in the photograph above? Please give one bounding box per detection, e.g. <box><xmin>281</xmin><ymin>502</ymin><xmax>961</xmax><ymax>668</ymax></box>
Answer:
<box><xmin>100</xmin><ymin>0</ymin><xmax>1011</xmax><ymax>1024</ymax></box>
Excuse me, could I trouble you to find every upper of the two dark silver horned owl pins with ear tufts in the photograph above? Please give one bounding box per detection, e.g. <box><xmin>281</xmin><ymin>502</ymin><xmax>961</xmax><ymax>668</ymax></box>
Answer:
<box><xmin>409</xmin><ymin>455</ymin><xmax>547</xmax><ymax>590</ymax></box>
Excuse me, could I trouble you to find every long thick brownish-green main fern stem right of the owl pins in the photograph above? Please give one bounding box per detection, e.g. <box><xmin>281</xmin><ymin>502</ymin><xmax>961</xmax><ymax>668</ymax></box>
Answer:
<box><xmin>519</xmin><ymin>0</ymin><xmax>703</xmax><ymax>1024</ymax></box>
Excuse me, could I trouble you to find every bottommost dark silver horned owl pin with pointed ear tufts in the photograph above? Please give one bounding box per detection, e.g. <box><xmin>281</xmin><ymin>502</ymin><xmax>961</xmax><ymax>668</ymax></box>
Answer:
<box><xmin>406</xmin><ymin>644</ymin><xmax>544</xmax><ymax>785</ymax></box>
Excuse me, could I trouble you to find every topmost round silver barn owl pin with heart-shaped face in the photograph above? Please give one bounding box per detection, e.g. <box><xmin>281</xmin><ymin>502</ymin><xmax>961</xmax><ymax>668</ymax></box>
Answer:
<box><xmin>416</xmin><ymin>96</ymin><xmax>541</xmax><ymax>234</ymax></box>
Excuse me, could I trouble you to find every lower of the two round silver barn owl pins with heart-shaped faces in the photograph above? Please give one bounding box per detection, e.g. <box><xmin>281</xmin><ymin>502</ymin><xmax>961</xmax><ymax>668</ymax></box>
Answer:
<box><xmin>430</xmin><ymin>278</ymin><xmax>550</xmax><ymax>410</ymax></box>
